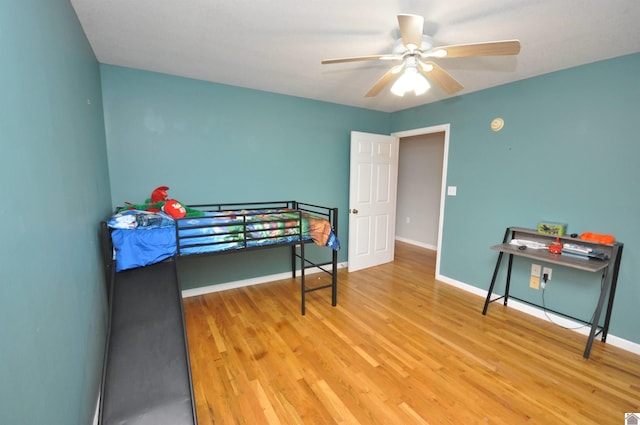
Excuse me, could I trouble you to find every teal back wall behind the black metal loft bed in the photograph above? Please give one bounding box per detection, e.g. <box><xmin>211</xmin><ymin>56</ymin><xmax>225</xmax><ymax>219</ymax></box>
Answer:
<box><xmin>101</xmin><ymin>65</ymin><xmax>391</xmax><ymax>288</ymax></box>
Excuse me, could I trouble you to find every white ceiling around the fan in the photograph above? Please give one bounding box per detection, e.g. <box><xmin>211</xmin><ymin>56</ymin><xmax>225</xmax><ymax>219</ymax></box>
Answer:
<box><xmin>71</xmin><ymin>0</ymin><xmax>640</xmax><ymax>112</ymax></box>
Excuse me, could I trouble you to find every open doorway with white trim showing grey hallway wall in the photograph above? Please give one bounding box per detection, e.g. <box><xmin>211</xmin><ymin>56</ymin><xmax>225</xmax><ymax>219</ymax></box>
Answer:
<box><xmin>393</xmin><ymin>124</ymin><xmax>449</xmax><ymax>276</ymax></box>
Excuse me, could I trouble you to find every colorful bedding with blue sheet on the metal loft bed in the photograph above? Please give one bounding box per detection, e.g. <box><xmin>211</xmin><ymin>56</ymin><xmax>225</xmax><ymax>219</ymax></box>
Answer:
<box><xmin>108</xmin><ymin>208</ymin><xmax>340</xmax><ymax>271</ymax></box>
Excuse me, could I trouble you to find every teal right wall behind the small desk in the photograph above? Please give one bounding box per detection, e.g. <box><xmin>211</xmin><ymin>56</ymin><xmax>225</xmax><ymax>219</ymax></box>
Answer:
<box><xmin>391</xmin><ymin>54</ymin><xmax>640</xmax><ymax>343</ymax></box>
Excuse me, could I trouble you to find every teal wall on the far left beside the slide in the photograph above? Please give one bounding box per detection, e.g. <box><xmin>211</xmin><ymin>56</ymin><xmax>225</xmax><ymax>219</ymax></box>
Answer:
<box><xmin>0</xmin><ymin>0</ymin><xmax>110</xmax><ymax>425</ymax></box>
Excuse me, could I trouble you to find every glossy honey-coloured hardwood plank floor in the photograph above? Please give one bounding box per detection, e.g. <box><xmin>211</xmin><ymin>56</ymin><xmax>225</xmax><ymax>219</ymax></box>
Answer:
<box><xmin>184</xmin><ymin>243</ymin><xmax>640</xmax><ymax>425</ymax></box>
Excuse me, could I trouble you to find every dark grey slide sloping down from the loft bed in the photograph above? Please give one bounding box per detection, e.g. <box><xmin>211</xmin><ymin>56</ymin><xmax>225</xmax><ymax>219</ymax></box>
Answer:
<box><xmin>99</xmin><ymin>261</ymin><xmax>197</xmax><ymax>425</ymax></box>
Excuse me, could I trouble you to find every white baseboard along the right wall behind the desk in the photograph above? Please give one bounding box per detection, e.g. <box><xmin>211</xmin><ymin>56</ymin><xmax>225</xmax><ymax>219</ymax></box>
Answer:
<box><xmin>436</xmin><ymin>275</ymin><xmax>640</xmax><ymax>354</ymax></box>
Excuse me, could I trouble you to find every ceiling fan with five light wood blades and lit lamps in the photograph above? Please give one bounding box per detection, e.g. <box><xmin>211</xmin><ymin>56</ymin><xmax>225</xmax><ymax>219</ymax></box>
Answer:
<box><xmin>322</xmin><ymin>14</ymin><xmax>520</xmax><ymax>97</ymax></box>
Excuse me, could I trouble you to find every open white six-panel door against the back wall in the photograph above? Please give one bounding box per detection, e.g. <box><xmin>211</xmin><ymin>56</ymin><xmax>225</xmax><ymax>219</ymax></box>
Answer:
<box><xmin>349</xmin><ymin>131</ymin><xmax>399</xmax><ymax>272</ymax></box>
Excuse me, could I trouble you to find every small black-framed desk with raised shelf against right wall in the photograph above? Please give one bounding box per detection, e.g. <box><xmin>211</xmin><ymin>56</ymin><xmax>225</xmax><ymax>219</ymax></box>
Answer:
<box><xmin>482</xmin><ymin>227</ymin><xmax>623</xmax><ymax>359</ymax></box>
